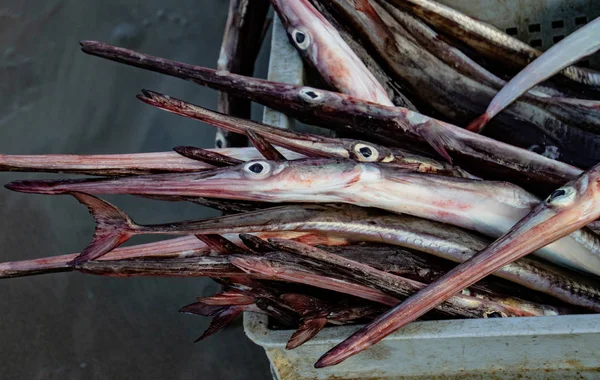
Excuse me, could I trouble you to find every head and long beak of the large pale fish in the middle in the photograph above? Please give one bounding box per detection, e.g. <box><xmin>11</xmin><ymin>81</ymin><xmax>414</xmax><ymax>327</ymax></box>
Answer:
<box><xmin>6</xmin><ymin>160</ymin><xmax>361</xmax><ymax>202</ymax></box>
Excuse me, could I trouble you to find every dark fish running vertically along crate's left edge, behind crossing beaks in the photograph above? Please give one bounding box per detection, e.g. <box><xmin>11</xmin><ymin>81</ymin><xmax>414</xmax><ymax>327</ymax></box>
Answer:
<box><xmin>215</xmin><ymin>0</ymin><xmax>270</xmax><ymax>148</ymax></box>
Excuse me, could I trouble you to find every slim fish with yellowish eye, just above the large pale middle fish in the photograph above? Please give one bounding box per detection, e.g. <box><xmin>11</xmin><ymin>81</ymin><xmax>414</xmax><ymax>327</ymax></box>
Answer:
<box><xmin>138</xmin><ymin>90</ymin><xmax>473</xmax><ymax>177</ymax></box>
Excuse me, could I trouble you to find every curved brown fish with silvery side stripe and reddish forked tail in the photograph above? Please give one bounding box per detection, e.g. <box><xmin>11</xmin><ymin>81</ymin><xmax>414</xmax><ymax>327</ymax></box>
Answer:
<box><xmin>36</xmin><ymin>194</ymin><xmax>600</xmax><ymax>311</ymax></box>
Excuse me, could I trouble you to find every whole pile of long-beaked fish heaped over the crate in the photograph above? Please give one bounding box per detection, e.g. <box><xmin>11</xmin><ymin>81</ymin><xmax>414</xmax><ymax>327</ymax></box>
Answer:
<box><xmin>0</xmin><ymin>0</ymin><xmax>600</xmax><ymax>367</ymax></box>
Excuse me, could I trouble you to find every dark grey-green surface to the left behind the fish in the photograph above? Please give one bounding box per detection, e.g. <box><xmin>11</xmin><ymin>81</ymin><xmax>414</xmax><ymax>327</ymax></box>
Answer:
<box><xmin>0</xmin><ymin>0</ymin><xmax>269</xmax><ymax>379</ymax></box>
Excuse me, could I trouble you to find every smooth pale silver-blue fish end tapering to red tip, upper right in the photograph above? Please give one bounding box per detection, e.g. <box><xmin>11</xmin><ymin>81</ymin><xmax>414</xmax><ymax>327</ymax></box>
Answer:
<box><xmin>467</xmin><ymin>17</ymin><xmax>600</xmax><ymax>132</ymax></box>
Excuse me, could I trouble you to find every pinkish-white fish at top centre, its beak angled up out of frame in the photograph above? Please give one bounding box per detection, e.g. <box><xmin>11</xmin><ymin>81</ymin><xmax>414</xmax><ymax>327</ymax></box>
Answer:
<box><xmin>270</xmin><ymin>0</ymin><xmax>394</xmax><ymax>106</ymax></box>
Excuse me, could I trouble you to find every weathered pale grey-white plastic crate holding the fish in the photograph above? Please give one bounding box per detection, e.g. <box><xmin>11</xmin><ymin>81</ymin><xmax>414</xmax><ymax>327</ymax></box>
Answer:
<box><xmin>244</xmin><ymin>0</ymin><xmax>600</xmax><ymax>380</ymax></box>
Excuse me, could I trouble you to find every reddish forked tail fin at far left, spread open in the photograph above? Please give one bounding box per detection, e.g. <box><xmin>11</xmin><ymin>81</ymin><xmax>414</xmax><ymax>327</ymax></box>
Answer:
<box><xmin>70</xmin><ymin>192</ymin><xmax>137</xmax><ymax>265</ymax></box>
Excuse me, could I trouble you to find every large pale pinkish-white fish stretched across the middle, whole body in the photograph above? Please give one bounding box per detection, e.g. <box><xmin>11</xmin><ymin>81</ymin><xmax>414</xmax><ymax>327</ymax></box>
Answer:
<box><xmin>6</xmin><ymin>159</ymin><xmax>600</xmax><ymax>275</ymax></box>
